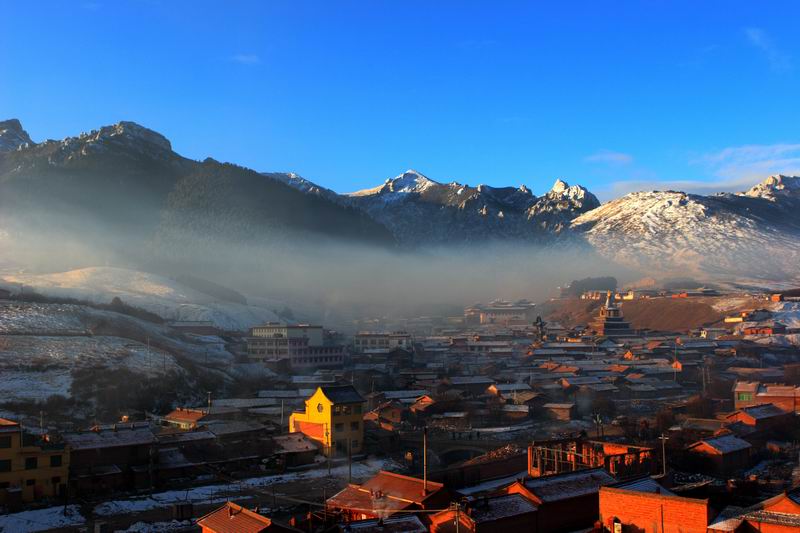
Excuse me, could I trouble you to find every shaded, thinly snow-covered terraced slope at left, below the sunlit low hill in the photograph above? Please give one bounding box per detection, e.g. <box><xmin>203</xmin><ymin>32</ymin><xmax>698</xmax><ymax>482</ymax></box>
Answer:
<box><xmin>0</xmin><ymin>301</ymin><xmax>242</xmax><ymax>401</ymax></box>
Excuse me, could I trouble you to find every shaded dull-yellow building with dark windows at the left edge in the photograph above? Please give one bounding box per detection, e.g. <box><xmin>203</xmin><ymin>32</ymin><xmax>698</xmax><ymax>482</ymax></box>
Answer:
<box><xmin>0</xmin><ymin>418</ymin><xmax>69</xmax><ymax>504</ymax></box>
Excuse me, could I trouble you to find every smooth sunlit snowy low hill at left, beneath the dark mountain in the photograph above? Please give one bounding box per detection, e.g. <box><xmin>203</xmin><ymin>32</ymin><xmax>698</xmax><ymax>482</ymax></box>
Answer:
<box><xmin>0</xmin><ymin>267</ymin><xmax>279</xmax><ymax>331</ymax></box>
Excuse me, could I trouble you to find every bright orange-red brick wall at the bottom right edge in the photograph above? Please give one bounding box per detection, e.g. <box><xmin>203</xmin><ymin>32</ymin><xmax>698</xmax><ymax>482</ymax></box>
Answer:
<box><xmin>600</xmin><ymin>487</ymin><xmax>709</xmax><ymax>533</ymax></box>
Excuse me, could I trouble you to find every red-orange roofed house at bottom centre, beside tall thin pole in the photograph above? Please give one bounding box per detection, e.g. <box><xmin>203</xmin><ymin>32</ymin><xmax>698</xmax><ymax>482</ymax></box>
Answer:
<box><xmin>327</xmin><ymin>470</ymin><xmax>449</xmax><ymax>522</ymax></box>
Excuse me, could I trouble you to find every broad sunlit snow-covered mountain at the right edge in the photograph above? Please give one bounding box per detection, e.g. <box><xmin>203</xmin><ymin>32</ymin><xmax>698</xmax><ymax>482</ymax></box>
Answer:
<box><xmin>572</xmin><ymin>177</ymin><xmax>800</xmax><ymax>281</ymax></box>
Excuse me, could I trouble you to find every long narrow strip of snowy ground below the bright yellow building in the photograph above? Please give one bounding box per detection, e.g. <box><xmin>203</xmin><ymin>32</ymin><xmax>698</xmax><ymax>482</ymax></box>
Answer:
<box><xmin>94</xmin><ymin>459</ymin><xmax>397</xmax><ymax>516</ymax></box>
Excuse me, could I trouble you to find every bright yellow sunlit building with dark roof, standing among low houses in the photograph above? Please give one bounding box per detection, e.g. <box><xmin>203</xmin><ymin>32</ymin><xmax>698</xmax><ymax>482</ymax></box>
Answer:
<box><xmin>289</xmin><ymin>385</ymin><xmax>364</xmax><ymax>457</ymax></box>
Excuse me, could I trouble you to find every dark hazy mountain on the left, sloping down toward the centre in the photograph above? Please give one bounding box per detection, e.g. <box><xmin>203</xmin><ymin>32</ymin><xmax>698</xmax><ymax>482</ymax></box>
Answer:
<box><xmin>0</xmin><ymin>120</ymin><xmax>394</xmax><ymax>268</ymax></box>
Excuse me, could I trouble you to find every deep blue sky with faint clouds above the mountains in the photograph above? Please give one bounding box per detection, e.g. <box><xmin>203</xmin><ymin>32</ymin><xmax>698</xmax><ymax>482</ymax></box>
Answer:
<box><xmin>0</xmin><ymin>0</ymin><xmax>800</xmax><ymax>198</ymax></box>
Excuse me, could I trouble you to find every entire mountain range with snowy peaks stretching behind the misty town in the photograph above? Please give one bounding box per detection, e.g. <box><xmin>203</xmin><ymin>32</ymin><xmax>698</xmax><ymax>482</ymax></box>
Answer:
<box><xmin>0</xmin><ymin>119</ymin><xmax>800</xmax><ymax>279</ymax></box>
